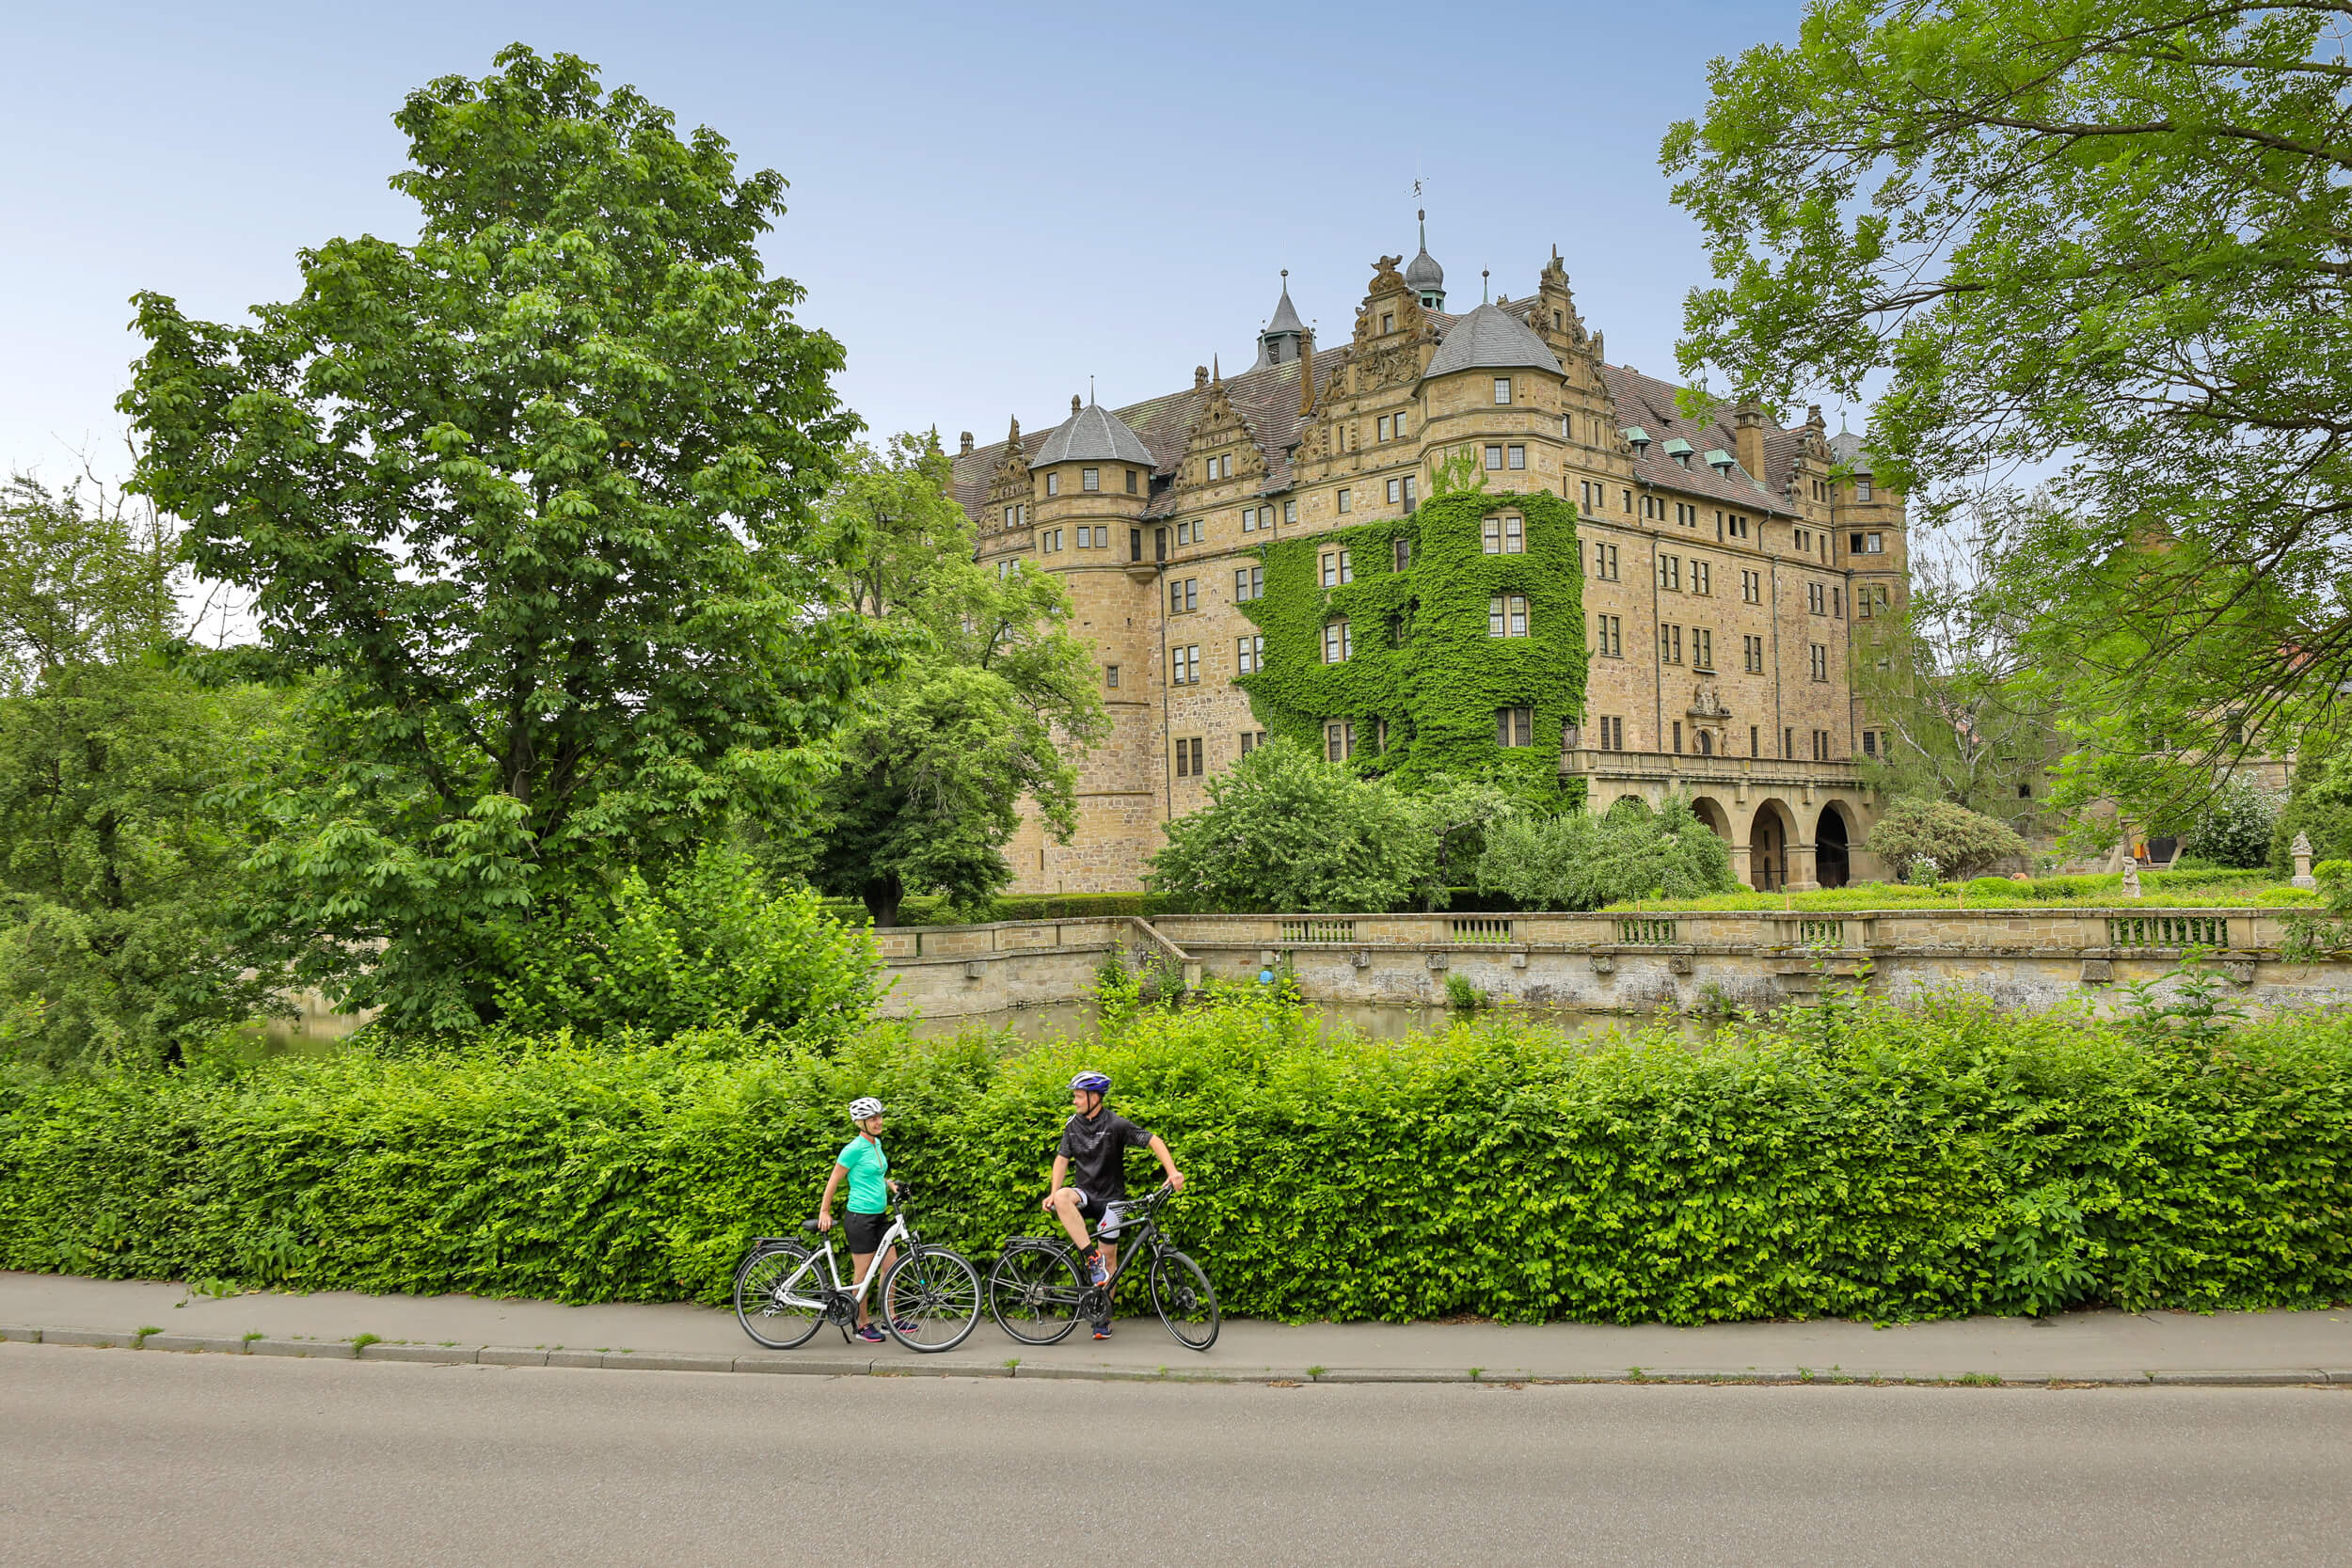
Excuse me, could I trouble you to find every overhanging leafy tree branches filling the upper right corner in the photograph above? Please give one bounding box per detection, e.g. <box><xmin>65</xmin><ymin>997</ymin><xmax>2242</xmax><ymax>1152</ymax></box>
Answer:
<box><xmin>1663</xmin><ymin>0</ymin><xmax>2352</xmax><ymax>814</ymax></box>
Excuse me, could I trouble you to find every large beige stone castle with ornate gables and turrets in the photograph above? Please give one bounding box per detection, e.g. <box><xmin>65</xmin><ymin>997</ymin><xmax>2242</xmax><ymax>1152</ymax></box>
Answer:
<box><xmin>953</xmin><ymin>217</ymin><xmax>1908</xmax><ymax>891</ymax></box>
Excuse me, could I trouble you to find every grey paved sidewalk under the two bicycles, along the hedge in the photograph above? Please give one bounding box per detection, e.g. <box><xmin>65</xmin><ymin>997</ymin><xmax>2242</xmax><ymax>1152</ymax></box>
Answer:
<box><xmin>0</xmin><ymin>1272</ymin><xmax>2352</xmax><ymax>1385</ymax></box>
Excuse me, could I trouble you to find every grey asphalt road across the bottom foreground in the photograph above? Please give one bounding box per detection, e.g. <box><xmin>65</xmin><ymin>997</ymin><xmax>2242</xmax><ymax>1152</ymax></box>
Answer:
<box><xmin>0</xmin><ymin>1345</ymin><xmax>2352</xmax><ymax>1568</ymax></box>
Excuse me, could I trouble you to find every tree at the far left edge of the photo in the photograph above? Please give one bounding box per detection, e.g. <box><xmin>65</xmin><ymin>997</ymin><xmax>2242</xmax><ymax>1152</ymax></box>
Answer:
<box><xmin>0</xmin><ymin>477</ymin><xmax>282</xmax><ymax>1068</ymax></box>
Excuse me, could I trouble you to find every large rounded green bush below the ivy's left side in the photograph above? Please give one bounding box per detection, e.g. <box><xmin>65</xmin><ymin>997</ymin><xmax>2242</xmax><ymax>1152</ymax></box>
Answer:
<box><xmin>1148</xmin><ymin>740</ymin><xmax>1438</xmax><ymax>914</ymax></box>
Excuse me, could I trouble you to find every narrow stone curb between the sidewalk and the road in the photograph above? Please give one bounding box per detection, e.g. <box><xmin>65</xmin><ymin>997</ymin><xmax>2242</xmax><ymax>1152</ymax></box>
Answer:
<box><xmin>0</xmin><ymin>1323</ymin><xmax>2352</xmax><ymax>1389</ymax></box>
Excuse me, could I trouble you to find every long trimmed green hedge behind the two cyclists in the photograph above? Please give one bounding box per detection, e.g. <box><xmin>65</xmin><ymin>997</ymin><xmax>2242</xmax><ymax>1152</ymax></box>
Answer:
<box><xmin>0</xmin><ymin>1002</ymin><xmax>2352</xmax><ymax>1323</ymax></box>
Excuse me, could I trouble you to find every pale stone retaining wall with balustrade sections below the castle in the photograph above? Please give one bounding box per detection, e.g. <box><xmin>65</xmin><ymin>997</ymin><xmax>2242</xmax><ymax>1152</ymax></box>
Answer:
<box><xmin>875</xmin><ymin>905</ymin><xmax>2352</xmax><ymax>1018</ymax></box>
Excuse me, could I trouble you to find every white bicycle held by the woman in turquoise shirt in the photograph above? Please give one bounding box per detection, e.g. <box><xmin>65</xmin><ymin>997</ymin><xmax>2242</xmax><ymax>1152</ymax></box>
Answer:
<box><xmin>734</xmin><ymin>1190</ymin><xmax>981</xmax><ymax>1354</ymax></box>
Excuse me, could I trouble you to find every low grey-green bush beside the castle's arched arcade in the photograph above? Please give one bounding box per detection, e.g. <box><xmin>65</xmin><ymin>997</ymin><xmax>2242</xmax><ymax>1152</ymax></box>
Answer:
<box><xmin>1477</xmin><ymin>800</ymin><xmax>1740</xmax><ymax>910</ymax></box>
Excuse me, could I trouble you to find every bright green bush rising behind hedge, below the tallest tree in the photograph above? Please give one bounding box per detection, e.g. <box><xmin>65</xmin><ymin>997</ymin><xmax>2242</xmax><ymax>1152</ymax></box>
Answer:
<box><xmin>497</xmin><ymin>848</ymin><xmax>882</xmax><ymax>1044</ymax></box>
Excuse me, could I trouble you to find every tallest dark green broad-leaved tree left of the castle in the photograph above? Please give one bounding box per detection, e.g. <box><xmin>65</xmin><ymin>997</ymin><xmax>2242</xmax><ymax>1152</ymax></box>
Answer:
<box><xmin>122</xmin><ymin>44</ymin><xmax>887</xmax><ymax>1027</ymax></box>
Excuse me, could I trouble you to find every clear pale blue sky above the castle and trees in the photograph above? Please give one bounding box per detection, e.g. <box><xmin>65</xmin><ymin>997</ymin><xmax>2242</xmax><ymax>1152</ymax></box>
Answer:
<box><xmin>0</xmin><ymin>0</ymin><xmax>1835</xmax><ymax>477</ymax></box>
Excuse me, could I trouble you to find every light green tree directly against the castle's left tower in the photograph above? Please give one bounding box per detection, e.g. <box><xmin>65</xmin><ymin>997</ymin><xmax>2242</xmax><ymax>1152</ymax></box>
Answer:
<box><xmin>814</xmin><ymin>433</ymin><xmax>1108</xmax><ymax>927</ymax></box>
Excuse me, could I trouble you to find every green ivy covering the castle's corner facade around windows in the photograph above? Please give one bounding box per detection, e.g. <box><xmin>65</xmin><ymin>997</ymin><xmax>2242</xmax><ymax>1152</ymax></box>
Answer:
<box><xmin>1237</xmin><ymin>491</ymin><xmax>1585</xmax><ymax>797</ymax></box>
